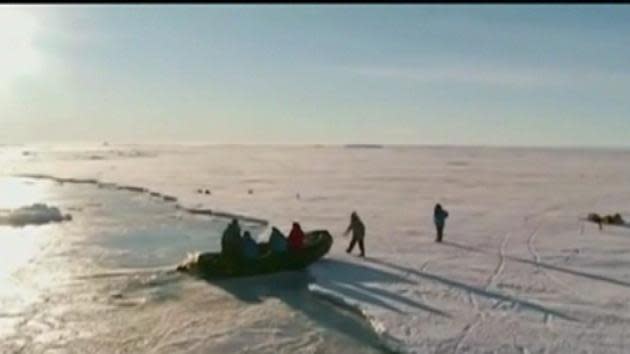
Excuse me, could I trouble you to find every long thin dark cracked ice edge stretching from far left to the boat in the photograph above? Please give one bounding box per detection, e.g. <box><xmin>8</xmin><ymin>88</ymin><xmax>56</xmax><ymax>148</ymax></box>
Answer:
<box><xmin>15</xmin><ymin>174</ymin><xmax>269</xmax><ymax>226</ymax></box>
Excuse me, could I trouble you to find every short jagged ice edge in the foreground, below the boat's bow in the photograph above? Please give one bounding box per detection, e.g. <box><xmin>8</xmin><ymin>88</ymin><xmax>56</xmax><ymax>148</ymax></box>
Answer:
<box><xmin>308</xmin><ymin>284</ymin><xmax>407</xmax><ymax>353</ymax></box>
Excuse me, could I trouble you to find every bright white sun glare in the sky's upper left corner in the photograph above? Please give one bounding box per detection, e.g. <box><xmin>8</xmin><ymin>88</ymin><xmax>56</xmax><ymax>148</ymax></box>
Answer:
<box><xmin>0</xmin><ymin>5</ymin><xmax>41</xmax><ymax>85</ymax></box>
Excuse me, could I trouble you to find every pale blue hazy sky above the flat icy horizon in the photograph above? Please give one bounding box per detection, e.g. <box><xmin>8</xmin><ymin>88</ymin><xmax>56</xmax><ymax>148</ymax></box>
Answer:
<box><xmin>0</xmin><ymin>4</ymin><xmax>630</xmax><ymax>147</ymax></box>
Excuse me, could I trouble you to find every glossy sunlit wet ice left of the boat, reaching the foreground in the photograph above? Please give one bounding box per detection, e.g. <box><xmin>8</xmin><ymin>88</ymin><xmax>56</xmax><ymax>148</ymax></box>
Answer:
<box><xmin>0</xmin><ymin>178</ymin><xmax>396</xmax><ymax>353</ymax></box>
